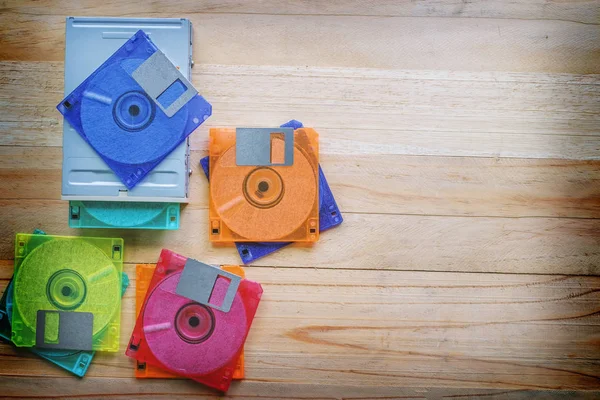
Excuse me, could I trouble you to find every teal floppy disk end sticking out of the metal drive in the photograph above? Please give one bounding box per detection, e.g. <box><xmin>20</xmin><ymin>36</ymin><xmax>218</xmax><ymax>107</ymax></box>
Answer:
<box><xmin>69</xmin><ymin>201</ymin><xmax>180</xmax><ymax>230</ymax></box>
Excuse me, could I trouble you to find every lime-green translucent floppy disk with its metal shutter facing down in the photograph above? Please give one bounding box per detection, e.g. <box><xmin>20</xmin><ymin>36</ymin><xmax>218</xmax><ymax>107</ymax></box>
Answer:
<box><xmin>11</xmin><ymin>233</ymin><xmax>123</xmax><ymax>352</ymax></box>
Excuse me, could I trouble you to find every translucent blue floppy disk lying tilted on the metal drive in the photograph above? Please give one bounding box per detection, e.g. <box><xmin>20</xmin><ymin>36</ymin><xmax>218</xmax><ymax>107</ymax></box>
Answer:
<box><xmin>57</xmin><ymin>30</ymin><xmax>212</xmax><ymax>189</ymax></box>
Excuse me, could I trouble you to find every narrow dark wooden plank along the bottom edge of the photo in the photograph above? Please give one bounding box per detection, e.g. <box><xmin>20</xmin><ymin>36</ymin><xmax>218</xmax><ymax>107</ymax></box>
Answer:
<box><xmin>0</xmin><ymin>376</ymin><xmax>600</xmax><ymax>400</ymax></box>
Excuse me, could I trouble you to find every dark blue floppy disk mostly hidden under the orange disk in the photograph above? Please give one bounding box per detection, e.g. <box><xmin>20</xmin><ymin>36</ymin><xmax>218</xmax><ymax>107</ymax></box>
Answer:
<box><xmin>200</xmin><ymin>120</ymin><xmax>343</xmax><ymax>264</ymax></box>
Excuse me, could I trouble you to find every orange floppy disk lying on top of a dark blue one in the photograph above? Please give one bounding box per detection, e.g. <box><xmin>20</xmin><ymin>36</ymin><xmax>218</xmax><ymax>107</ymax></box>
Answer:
<box><xmin>209</xmin><ymin>128</ymin><xmax>319</xmax><ymax>244</ymax></box>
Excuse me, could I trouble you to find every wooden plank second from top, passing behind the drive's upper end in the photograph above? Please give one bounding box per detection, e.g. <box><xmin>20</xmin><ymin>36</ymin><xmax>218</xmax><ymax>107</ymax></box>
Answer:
<box><xmin>0</xmin><ymin>11</ymin><xmax>600</xmax><ymax>74</ymax></box>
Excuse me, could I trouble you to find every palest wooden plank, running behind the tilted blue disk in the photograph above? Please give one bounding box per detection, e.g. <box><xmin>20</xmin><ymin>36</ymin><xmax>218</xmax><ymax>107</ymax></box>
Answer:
<box><xmin>0</xmin><ymin>62</ymin><xmax>600</xmax><ymax>159</ymax></box>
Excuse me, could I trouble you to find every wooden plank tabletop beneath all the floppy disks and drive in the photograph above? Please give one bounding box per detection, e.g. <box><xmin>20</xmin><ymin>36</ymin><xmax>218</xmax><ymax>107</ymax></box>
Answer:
<box><xmin>0</xmin><ymin>0</ymin><xmax>600</xmax><ymax>399</ymax></box>
